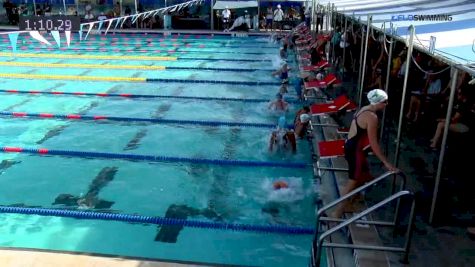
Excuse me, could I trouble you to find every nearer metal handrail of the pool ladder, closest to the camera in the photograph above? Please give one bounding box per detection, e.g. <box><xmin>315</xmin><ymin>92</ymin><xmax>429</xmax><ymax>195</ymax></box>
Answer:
<box><xmin>312</xmin><ymin>191</ymin><xmax>415</xmax><ymax>266</ymax></box>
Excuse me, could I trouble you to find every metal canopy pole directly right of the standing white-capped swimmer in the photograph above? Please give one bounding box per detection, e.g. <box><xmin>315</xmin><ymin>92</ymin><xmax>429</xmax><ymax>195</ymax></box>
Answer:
<box><xmin>394</xmin><ymin>25</ymin><xmax>414</xmax><ymax>167</ymax></box>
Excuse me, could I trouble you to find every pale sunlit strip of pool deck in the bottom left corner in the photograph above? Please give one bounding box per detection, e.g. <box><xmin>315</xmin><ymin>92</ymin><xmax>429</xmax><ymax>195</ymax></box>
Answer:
<box><xmin>0</xmin><ymin>249</ymin><xmax>209</xmax><ymax>267</ymax></box>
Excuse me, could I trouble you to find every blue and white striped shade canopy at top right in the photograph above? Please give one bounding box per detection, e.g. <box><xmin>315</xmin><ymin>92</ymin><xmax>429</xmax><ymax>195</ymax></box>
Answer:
<box><xmin>319</xmin><ymin>0</ymin><xmax>475</xmax><ymax>69</ymax></box>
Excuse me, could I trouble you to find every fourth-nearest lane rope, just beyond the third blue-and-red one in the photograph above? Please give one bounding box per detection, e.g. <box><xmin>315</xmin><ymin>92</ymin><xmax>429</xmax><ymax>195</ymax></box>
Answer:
<box><xmin>0</xmin><ymin>89</ymin><xmax>300</xmax><ymax>103</ymax></box>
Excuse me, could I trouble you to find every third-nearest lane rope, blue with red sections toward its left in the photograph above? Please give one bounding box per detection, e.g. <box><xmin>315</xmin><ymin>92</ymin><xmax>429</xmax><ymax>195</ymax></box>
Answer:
<box><xmin>0</xmin><ymin>111</ymin><xmax>275</xmax><ymax>129</ymax></box>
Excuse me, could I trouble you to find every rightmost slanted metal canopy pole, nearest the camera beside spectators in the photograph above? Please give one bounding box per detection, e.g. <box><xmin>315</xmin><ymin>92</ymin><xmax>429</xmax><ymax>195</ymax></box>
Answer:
<box><xmin>429</xmin><ymin>69</ymin><xmax>458</xmax><ymax>223</ymax></box>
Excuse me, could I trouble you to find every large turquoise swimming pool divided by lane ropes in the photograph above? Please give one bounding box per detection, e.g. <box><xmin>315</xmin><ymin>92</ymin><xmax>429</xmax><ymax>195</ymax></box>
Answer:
<box><xmin>0</xmin><ymin>34</ymin><xmax>314</xmax><ymax>266</ymax></box>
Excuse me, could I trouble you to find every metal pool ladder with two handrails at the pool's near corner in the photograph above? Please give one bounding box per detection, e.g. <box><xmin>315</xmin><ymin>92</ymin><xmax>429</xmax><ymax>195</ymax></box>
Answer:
<box><xmin>310</xmin><ymin>171</ymin><xmax>415</xmax><ymax>267</ymax></box>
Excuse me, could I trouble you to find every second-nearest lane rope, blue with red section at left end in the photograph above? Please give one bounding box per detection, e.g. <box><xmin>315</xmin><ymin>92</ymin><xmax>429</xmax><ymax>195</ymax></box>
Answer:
<box><xmin>0</xmin><ymin>147</ymin><xmax>308</xmax><ymax>169</ymax></box>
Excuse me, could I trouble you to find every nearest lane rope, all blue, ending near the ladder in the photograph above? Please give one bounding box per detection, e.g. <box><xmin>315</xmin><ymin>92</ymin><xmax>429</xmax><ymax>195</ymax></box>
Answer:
<box><xmin>0</xmin><ymin>206</ymin><xmax>315</xmax><ymax>235</ymax></box>
